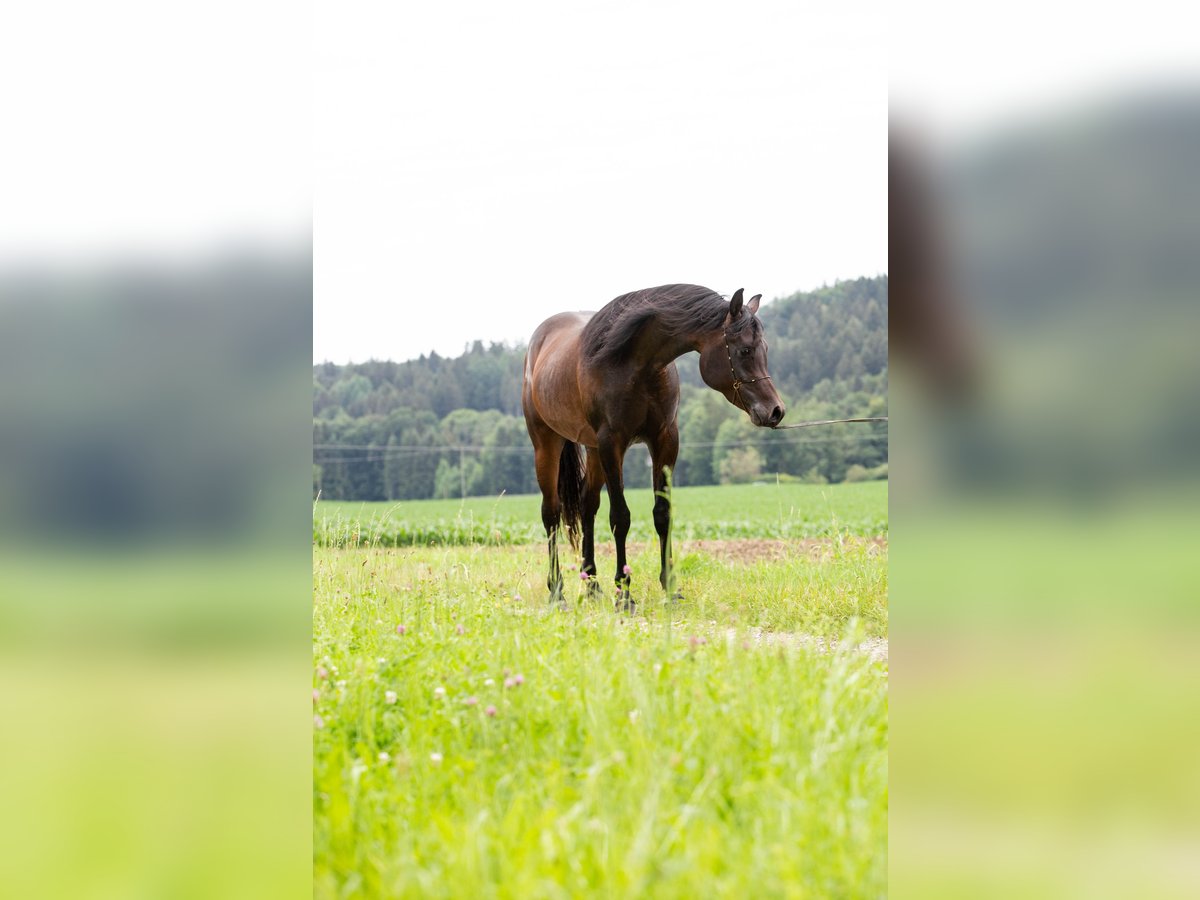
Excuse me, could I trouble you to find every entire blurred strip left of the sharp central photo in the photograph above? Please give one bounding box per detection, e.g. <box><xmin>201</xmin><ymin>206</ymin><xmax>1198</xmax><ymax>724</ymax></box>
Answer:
<box><xmin>0</xmin><ymin>0</ymin><xmax>312</xmax><ymax>898</ymax></box>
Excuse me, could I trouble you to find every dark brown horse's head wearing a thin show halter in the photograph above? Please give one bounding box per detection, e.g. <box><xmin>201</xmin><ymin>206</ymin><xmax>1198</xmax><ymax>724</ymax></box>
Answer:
<box><xmin>700</xmin><ymin>288</ymin><xmax>784</xmax><ymax>428</ymax></box>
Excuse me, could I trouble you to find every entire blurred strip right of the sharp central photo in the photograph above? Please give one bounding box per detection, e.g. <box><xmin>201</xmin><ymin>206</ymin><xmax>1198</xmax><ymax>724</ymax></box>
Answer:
<box><xmin>889</xmin><ymin>5</ymin><xmax>1200</xmax><ymax>898</ymax></box>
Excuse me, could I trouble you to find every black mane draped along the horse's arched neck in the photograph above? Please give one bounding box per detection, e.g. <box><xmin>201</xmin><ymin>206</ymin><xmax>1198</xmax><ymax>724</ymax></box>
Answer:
<box><xmin>580</xmin><ymin>284</ymin><xmax>730</xmax><ymax>362</ymax></box>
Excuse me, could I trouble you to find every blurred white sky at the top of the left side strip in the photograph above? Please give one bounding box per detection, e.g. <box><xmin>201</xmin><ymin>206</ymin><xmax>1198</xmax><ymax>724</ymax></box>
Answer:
<box><xmin>0</xmin><ymin>0</ymin><xmax>312</xmax><ymax>265</ymax></box>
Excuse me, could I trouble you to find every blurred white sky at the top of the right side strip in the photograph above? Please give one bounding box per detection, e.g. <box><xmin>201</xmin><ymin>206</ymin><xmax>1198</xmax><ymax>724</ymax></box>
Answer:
<box><xmin>889</xmin><ymin>0</ymin><xmax>1200</xmax><ymax>144</ymax></box>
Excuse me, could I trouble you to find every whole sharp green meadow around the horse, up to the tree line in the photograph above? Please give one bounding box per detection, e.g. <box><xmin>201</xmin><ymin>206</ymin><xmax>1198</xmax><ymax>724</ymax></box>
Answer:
<box><xmin>313</xmin><ymin>484</ymin><xmax>888</xmax><ymax>898</ymax></box>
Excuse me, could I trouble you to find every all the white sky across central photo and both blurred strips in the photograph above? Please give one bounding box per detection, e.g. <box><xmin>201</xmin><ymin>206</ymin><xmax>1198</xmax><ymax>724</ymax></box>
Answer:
<box><xmin>7</xmin><ymin>0</ymin><xmax>1200</xmax><ymax>361</ymax></box>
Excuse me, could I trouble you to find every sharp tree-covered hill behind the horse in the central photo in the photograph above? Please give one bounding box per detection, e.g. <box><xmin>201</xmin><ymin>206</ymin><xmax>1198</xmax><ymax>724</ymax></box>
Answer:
<box><xmin>313</xmin><ymin>275</ymin><xmax>888</xmax><ymax>500</ymax></box>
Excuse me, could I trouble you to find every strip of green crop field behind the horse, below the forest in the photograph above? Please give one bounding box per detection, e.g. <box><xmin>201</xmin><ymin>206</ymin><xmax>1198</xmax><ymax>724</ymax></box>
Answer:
<box><xmin>313</xmin><ymin>481</ymin><xmax>888</xmax><ymax>547</ymax></box>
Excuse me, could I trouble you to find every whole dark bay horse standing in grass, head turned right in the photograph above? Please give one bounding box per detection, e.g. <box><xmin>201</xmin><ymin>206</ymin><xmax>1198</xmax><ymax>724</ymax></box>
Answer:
<box><xmin>521</xmin><ymin>284</ymin><xmax>784</xmax><ymax>602</ymax></box>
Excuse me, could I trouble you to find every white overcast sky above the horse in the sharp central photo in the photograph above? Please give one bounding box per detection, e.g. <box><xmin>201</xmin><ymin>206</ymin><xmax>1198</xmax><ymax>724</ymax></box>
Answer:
<box><xmin>313</xmin><ymin>0</ymin><xmax>888</xmax><ymax>362</ymax></box>
